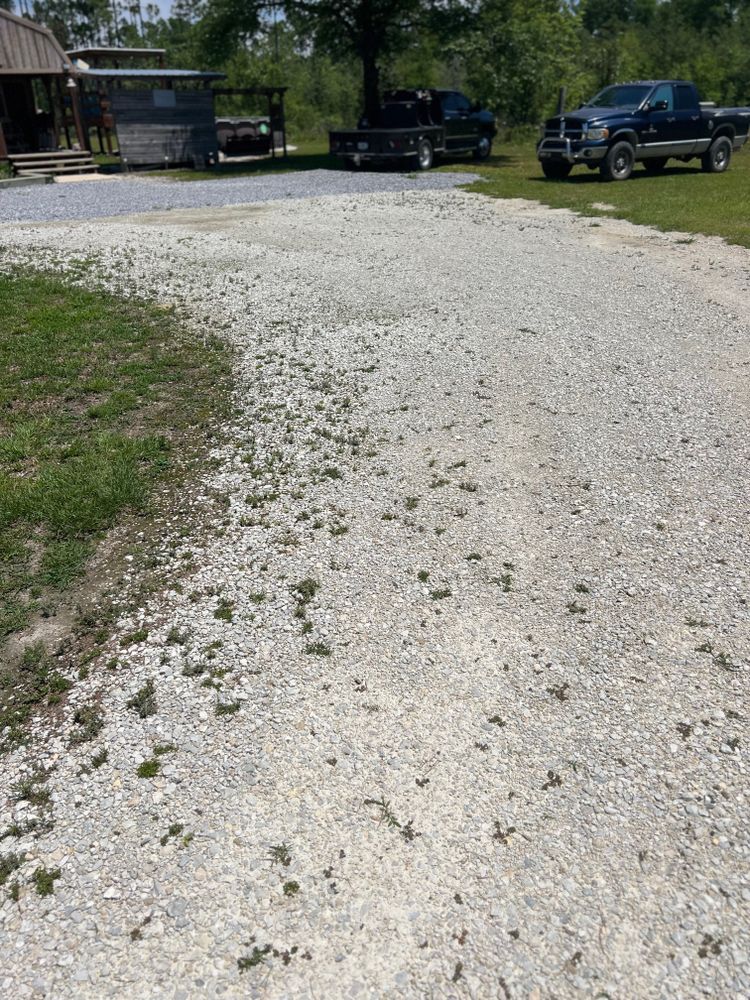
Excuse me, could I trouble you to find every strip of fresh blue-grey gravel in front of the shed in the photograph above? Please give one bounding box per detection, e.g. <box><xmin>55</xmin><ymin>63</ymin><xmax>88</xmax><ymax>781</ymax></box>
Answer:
<box><xmin>0</xmin><ymin>170</ymin><xmax>476</xmax><ymax>223</ymax></box>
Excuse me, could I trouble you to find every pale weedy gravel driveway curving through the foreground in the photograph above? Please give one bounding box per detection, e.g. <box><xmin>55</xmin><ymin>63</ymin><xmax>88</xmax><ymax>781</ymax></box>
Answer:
<box><xmin>0</xmin><ymin>185</ymin><xmax>750</xmax><ymax>1000</ymax></box>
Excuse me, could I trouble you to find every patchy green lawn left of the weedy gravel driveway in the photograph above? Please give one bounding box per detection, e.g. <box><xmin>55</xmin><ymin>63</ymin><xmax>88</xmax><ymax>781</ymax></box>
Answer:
<box><xmin>0</xmin><ymin>273</ymin><xmax>226</xmax><ymax>644</ymax></box>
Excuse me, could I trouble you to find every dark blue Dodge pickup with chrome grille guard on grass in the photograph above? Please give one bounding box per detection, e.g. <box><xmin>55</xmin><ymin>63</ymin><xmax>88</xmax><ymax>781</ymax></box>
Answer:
<box><xmin>537</xmin><ymin>80</ymin><xmax>750</xmax><ymax>181</ymax></box>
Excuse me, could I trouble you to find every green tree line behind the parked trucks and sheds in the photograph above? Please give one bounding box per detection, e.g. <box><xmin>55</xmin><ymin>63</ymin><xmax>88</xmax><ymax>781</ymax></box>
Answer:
<box><xmin>8</xmin><ymin>0</ymin><xmax>750</xmax><ymax>137</ymax></box>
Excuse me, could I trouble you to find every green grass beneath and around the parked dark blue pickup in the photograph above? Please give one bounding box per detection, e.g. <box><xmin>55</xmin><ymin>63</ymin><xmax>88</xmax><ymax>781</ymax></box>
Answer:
<box><xmin>441</xmin><ymin>136</ymin><xmax>750</xmax><ymax>247</ymax></box>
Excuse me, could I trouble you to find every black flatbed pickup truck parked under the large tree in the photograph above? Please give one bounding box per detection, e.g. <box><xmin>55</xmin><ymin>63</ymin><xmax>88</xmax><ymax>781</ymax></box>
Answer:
<box><xmin>329</xmin><ymin>89</ymin><xmax>497</xmax><ymax>170</ymax></box>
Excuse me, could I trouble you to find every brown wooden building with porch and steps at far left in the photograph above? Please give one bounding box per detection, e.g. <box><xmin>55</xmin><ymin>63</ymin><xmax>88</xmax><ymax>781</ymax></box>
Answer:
<box><xmin>0</xmin><ymin>8</ymin><xmax>85</xmax><ymax>159</ymax></box>
